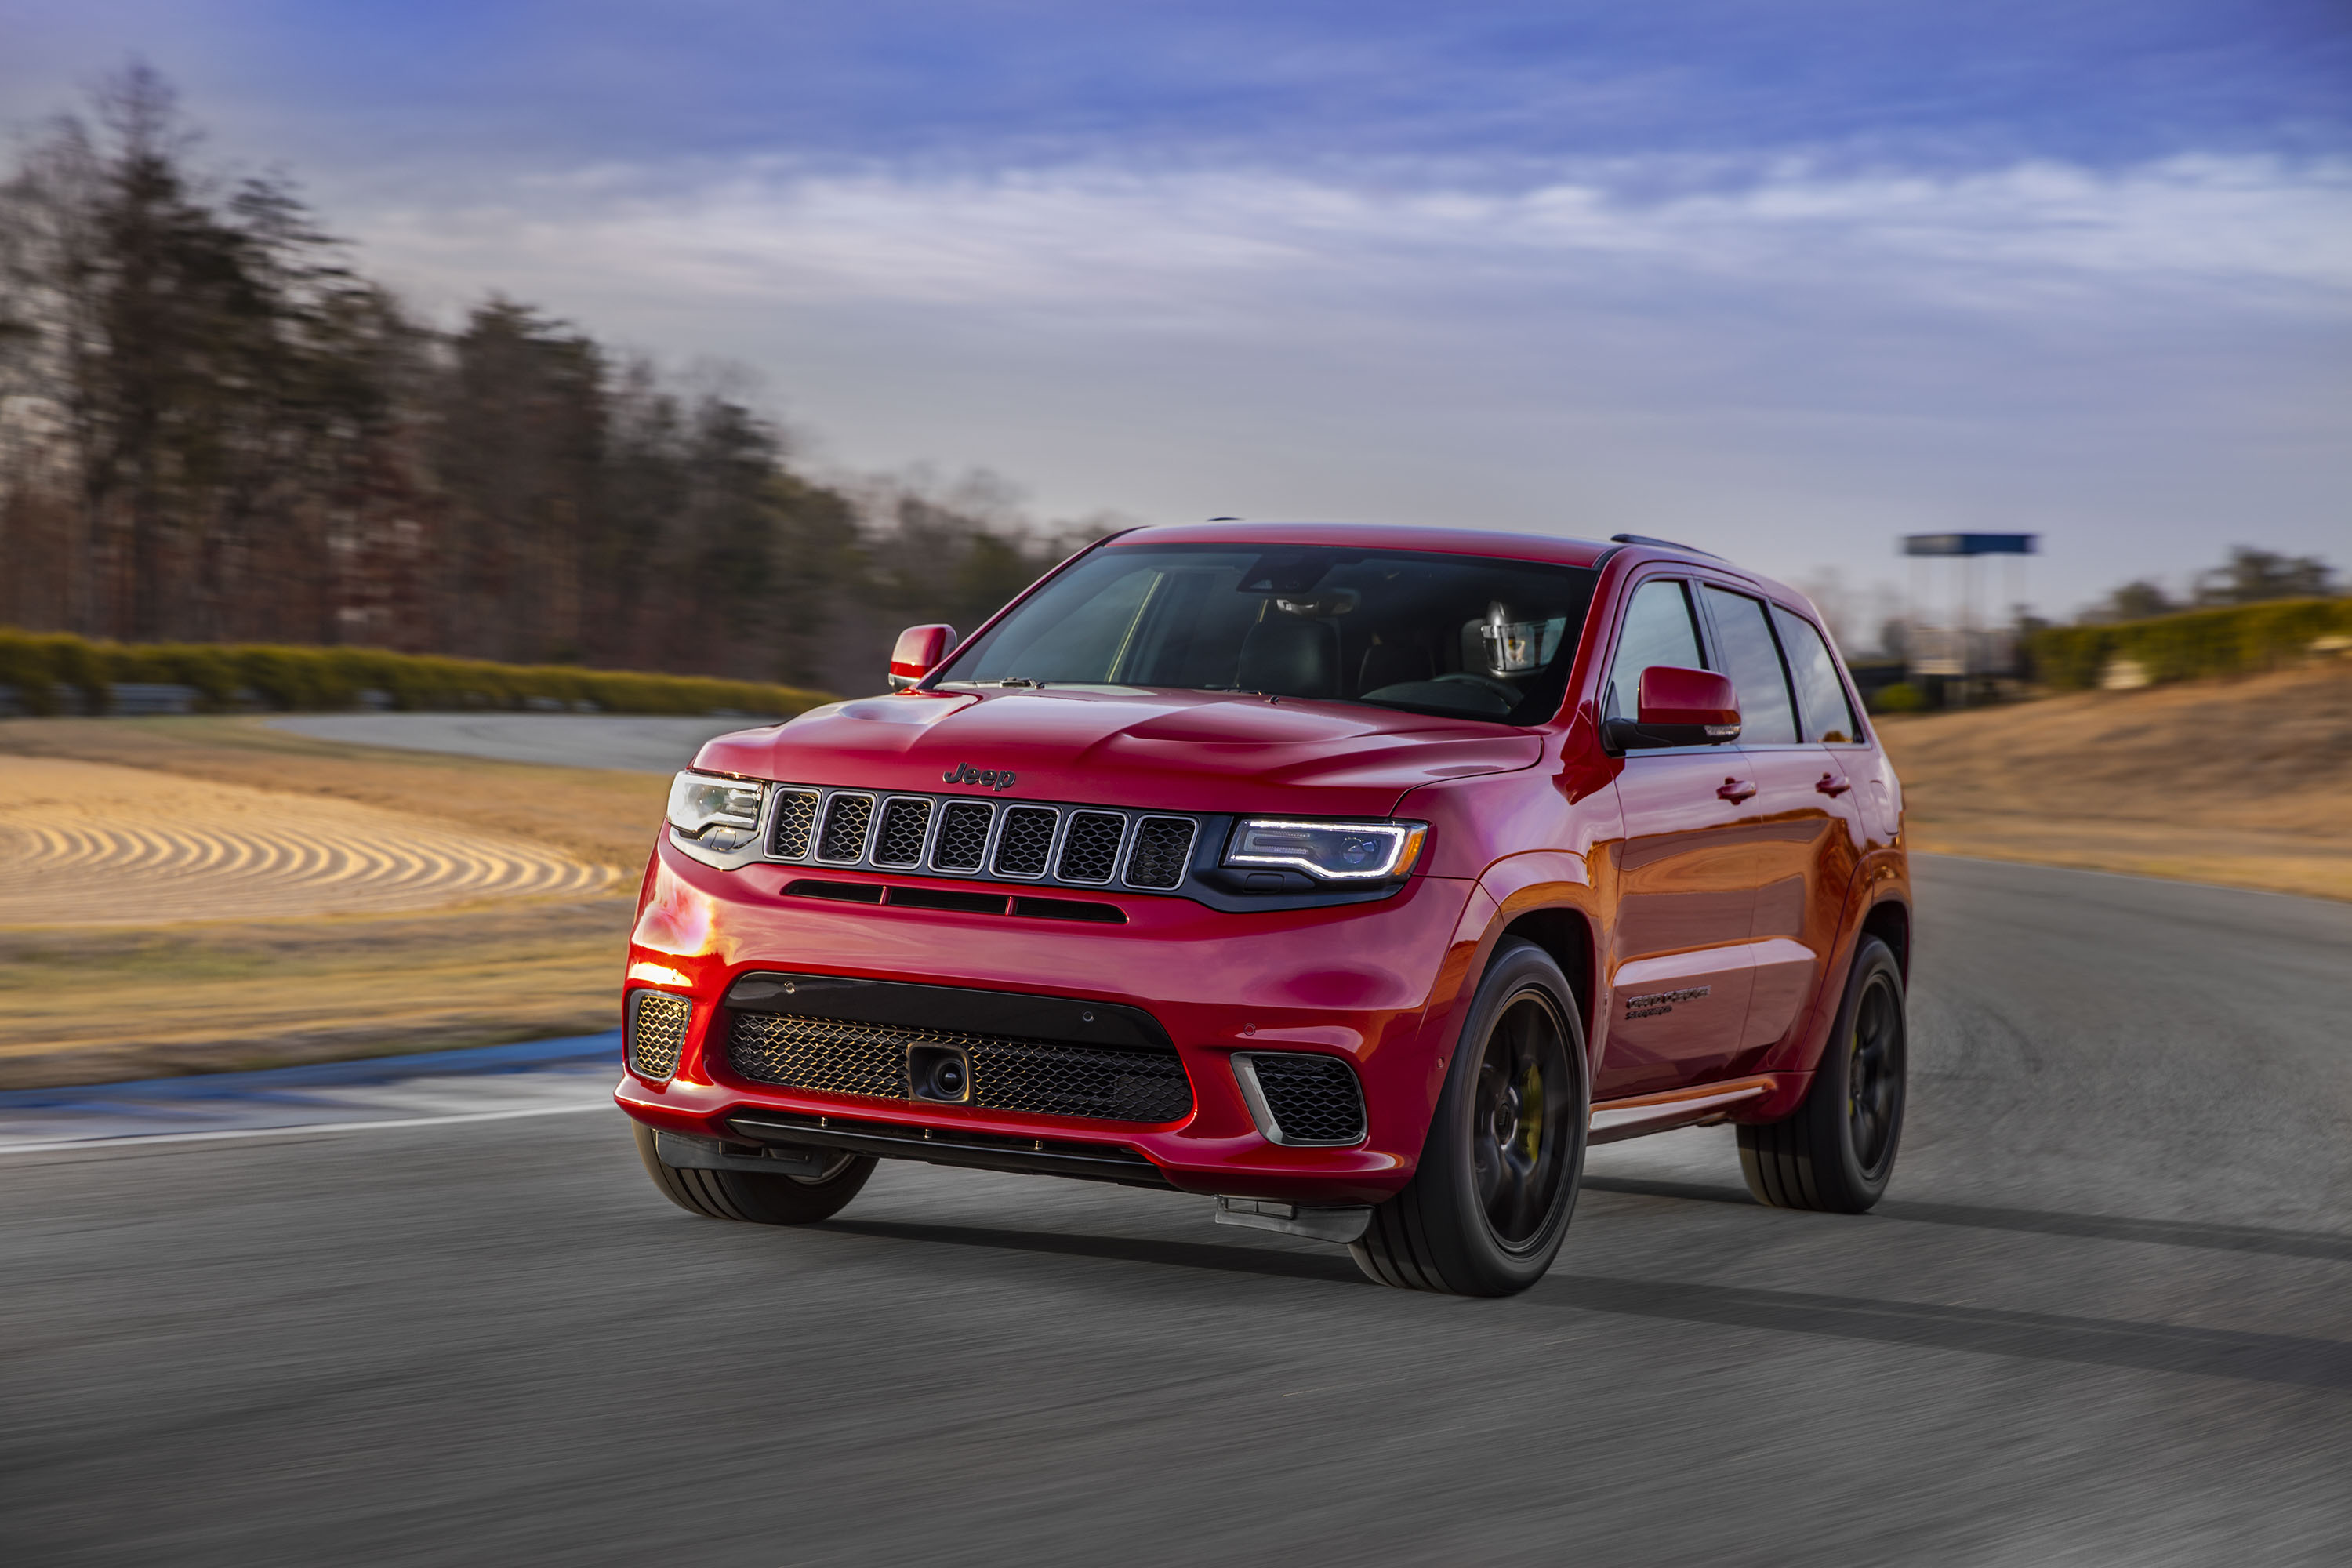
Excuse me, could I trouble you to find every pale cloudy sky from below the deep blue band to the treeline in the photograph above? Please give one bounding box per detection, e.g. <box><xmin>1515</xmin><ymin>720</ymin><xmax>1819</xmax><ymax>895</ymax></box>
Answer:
<box><xmin>348</xmin><ymin>158</ymin><xmax>2352</xmax><ymax>607</ymax></box>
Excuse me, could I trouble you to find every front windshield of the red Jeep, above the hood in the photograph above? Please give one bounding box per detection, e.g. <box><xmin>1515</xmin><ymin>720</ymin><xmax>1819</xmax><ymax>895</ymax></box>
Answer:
<box><xmin>938</xmin><ymin>546</ymin><xmax>1597</xmax><ymax>724</ymax></box>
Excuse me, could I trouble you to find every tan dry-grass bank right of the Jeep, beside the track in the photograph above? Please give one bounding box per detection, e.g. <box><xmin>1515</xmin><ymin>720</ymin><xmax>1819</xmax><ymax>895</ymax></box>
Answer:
<box><xmin>1879</xmin><ymin>663</ymin><xmax>2352</xmax><ymax>900</ymax></box>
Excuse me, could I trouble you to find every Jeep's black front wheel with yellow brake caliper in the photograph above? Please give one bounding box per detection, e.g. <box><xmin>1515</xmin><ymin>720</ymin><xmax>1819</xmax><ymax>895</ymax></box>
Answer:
<box><xmin>1348</xmin><ymin>938</ymin><xmax>1592</xmax><ymax>1295</ymax></box>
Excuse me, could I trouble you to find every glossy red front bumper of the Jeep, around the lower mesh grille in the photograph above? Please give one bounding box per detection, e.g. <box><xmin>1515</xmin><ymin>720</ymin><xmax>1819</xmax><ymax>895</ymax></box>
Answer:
<box><xmin>614</xmin><ymin>841</ymin><xmax>1472</xmax><ymax>1203</ymax></box>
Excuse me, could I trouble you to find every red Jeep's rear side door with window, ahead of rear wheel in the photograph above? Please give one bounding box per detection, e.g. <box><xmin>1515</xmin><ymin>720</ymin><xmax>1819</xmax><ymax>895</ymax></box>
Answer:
<box><xmin>1698</xmin><ymin>583</ymin><xmax>1853</xmax><ymax>1074</ymax></box>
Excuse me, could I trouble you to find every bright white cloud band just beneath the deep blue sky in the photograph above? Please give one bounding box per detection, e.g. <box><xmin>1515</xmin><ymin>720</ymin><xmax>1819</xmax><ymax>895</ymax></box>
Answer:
<box><xmin>365</xmin><ymin>158</ymin><xmax>2352</xmax><ymax>325</ymax></box>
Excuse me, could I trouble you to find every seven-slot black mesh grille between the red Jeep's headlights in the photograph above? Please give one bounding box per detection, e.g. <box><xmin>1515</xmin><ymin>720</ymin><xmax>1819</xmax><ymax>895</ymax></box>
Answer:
<box><xmin>767</xmin><ymin>785</ymin><xmax>1200</xmax><ymax>893</ymax></box>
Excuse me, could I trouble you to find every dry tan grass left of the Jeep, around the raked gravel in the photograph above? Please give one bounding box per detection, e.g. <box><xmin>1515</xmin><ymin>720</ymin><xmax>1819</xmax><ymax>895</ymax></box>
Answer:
<box><xmin>0</xmin><ymin>717</ymin><xmax>668</xmax><ymax>1088</ymax></box>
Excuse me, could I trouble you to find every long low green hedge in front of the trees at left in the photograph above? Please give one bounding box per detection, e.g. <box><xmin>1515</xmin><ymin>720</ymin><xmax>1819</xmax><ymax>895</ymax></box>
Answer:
<box><xmin>0</xmin><ymin>628</ymin><xmax>833</xmax><ymax>715</ymax></box>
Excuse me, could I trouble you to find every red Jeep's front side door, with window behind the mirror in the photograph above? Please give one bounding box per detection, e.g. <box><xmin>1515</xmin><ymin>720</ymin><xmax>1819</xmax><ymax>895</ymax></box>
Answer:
<box><xmin>1592</xmin><ymin>576</ymin><xmax>1755</xmax><ymax>1100</ymax></box>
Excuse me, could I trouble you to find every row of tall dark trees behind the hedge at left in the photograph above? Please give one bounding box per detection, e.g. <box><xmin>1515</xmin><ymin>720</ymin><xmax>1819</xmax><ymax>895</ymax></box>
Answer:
<box><xmin>0</xmin><ymin>66</ymin><xmax>1129</xmax><ymax>689</ymax></box>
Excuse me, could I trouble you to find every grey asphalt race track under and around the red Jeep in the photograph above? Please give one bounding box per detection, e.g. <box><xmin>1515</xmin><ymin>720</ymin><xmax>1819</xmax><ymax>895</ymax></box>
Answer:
<box><xmin>0</xmin><ymin>728</ymin><xmax>2352</xmax><ymax>1568</ymax></box>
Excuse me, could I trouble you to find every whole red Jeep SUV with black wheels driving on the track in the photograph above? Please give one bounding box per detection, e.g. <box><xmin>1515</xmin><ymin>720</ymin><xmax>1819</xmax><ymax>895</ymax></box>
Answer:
<box><xmin>616</xmin><ymin>524</ymin><xmax>1910</xmax><ymax>1295</ymax></box>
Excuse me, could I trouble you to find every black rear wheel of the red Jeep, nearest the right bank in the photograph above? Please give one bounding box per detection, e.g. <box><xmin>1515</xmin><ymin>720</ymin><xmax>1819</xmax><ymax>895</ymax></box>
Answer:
<box><xmin>1740</xmin><ymin>935</ymin><xmax>1907</xmax><ymax>1213</ymax></box>
